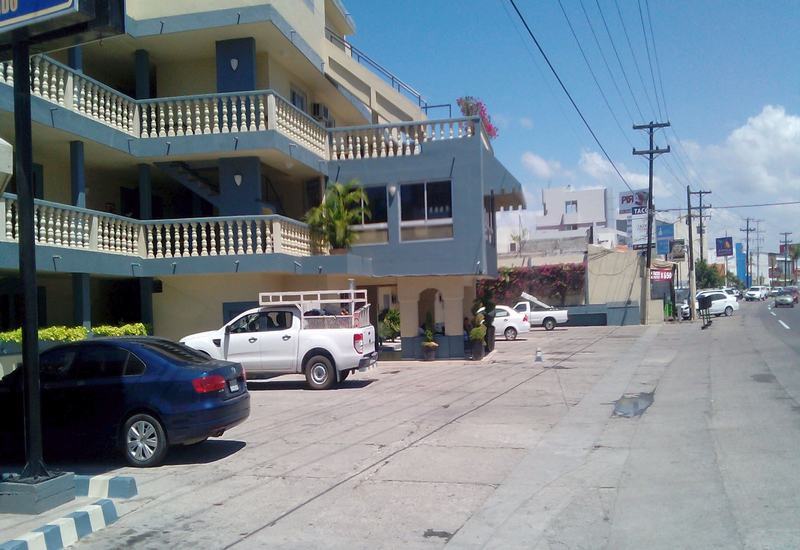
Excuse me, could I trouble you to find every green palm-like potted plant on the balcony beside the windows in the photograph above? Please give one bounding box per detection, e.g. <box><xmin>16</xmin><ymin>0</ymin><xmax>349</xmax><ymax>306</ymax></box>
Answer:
<box><xmin>305</xmin><ymin>180</ymin><xmax>371</xmax><ymax>254</ymax></box>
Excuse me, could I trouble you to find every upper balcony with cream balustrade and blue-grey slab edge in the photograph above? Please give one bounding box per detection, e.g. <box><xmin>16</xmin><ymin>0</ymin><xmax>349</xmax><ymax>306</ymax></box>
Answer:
<box><xmin>0</xmin><ymin>55</ymin><xmax>329</xmax><ymax>164</ymax></box>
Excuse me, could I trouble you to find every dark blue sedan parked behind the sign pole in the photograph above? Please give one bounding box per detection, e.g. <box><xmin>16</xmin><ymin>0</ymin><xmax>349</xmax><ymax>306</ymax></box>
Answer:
<box><xmin>0</xmin><ymin>337</ymin><xmax>250</xmax><ymax>467</ymax></box>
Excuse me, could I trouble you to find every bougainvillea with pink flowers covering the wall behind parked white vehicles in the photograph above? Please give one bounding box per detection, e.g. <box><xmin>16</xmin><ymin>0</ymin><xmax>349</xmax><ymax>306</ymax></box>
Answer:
<box><xmin>477</xmin><ymin>264</ymin><xmax>586</xmax><ymax>306</ymax></box>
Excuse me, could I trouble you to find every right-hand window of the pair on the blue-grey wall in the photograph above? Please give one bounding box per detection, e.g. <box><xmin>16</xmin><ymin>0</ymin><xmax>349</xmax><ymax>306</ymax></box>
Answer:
<box><xmin>400</xmin><ymin>181</ymin><xmax>453</xmax><ymax>241</ymax></box>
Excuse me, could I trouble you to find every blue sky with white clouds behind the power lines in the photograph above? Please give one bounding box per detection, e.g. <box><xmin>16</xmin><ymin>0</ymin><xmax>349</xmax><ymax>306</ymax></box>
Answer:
<box><xmin>345</xmin><ymin>0</ymin><xmax>800</xmax><ymax>258</ymax></box>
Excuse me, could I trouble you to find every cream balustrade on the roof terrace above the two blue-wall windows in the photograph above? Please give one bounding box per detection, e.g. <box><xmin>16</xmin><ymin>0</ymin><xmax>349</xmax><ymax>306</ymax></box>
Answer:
<box><xmin>330</xmin><ymin>118</ymin><xmax>480</xmax><ymax>160</ymax></box>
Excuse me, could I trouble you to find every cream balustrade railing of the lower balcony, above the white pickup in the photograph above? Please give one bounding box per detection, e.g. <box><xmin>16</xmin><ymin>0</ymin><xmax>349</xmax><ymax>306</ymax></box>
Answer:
<box><xmin>0</xmin><ymin>194</ymin><xmax>324</xmax><ymax>258</ymax></box>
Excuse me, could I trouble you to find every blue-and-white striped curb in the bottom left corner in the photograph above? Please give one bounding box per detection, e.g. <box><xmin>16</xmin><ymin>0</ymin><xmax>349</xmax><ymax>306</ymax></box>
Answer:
<box><xmin>0</xmin><ymin>499</ymin><xmax>118</xmax><ymax>550</ymax></box>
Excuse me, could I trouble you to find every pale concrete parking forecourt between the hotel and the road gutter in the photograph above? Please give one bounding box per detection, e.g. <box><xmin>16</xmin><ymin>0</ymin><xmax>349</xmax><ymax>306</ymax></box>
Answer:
<box><xmin>9</xmin><ymin>327</ymin><xmax>624</xmax><ymax>548</ymax></box>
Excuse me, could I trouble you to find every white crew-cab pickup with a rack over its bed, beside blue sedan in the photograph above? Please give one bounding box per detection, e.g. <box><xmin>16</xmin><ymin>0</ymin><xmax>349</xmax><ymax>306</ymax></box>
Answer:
<box><xmin>181</xmin><ymin>290</ymin><xmax>378</xmax><ymax>390</ymax></box>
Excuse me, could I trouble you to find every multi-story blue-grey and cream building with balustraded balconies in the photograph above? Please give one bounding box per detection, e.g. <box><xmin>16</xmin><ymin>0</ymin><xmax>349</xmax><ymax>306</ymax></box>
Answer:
<box><xmin>0</xmin><ymin>0</ymin><xmax>524</xmax><ymax>357</ymax></box>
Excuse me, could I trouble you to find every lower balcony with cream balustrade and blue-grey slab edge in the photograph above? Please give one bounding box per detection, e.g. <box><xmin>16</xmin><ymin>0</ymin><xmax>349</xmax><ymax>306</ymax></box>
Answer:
<box><xmin>0</xmin><ymin>193</ymin><xmax>371</xmax><ymax>277</ymax></box>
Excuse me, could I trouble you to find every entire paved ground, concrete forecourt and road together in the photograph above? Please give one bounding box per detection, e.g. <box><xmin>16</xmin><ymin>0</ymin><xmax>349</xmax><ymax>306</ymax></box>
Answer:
<box><xmin>34</xmin><ymin>302</ymin><xmax>800</xmax><ymax>548</ymax></box>
